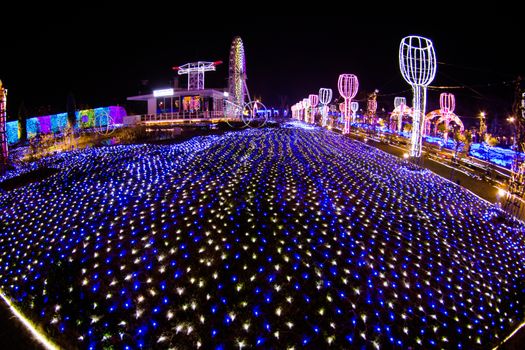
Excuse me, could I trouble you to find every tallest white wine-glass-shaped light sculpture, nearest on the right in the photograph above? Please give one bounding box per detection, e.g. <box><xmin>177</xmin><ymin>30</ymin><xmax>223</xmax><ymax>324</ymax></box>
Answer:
<box><xmin>399</xmin><ymin>35</ymin><xmax>436</xmax><ymax>160</ymax></box>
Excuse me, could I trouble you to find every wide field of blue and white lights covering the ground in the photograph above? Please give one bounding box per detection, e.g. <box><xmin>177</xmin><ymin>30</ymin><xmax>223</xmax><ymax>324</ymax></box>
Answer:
<box><xmin>0</xmin><ymin>126</ymin><xmax>525</xmax><ymax>349</ymax></box>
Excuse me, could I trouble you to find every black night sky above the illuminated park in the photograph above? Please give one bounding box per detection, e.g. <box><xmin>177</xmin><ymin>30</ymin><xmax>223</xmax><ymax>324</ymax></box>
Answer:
<box><xmin>0</xmin><ymin>14</ymin><xmax>525</xmax><ymax>129</ymax></box>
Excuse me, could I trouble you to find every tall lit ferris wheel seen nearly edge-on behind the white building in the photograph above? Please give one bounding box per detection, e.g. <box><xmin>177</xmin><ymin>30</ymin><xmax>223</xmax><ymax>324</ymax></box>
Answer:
<box><xmin>228</xmin><ymin>36</ymin><xmax>251</xmax><ymax>108</ymax></box>
